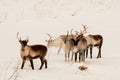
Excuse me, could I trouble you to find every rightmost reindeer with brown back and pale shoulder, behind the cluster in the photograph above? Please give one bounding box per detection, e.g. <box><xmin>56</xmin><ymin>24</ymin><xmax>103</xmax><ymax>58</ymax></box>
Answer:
<box><xmin>82</xmin><ymin>25</ymin><xmax>103</xmax><ymax>58</ymax></box>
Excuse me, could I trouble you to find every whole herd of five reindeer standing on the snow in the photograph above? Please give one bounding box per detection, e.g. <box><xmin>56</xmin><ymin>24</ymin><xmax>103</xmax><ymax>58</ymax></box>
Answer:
<box><xmin>17</xmin><ymin>25</ymin><xmax>103</xmax><ymax>69</ymax></box>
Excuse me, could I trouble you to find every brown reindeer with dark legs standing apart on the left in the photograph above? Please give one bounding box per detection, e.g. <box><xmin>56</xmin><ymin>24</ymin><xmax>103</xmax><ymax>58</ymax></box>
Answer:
<box><xmin>17</xmin><ymin>33</ymin><xmax>47</xmax><ymax>70</ymax></box>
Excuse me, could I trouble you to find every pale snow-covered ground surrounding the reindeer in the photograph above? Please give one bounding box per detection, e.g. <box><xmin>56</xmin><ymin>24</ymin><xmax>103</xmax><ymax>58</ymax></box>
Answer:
<box><xmin>0</xmin><ymin>0</ymin><xmax>120</xmax><ymax>80</ymax></box>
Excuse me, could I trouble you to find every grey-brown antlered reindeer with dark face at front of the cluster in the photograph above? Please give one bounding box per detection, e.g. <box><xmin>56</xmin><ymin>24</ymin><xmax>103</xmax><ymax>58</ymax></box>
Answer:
<box><xmin>71</xmin><ymin>27</ymin><xmax>87</xmax><ymax>62</ymax></box>
